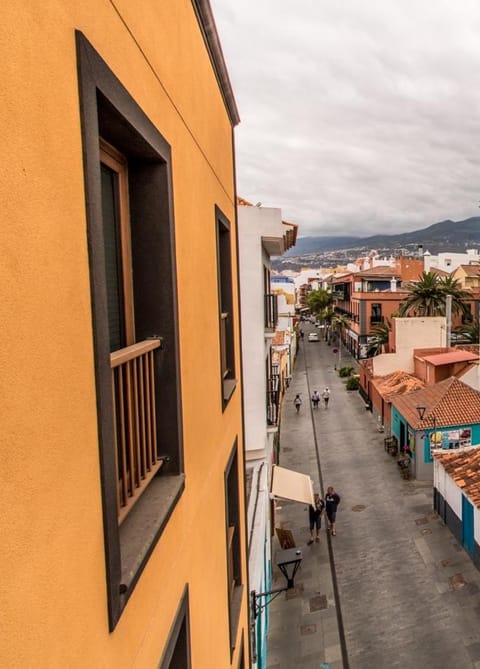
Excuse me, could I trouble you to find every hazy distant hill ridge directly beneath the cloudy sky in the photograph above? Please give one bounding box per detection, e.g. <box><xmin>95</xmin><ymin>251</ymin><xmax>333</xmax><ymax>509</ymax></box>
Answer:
<box><xmin>282</xmin><ymin>216</ymin><xmax>480</xmax><ymax>258</ymax></box>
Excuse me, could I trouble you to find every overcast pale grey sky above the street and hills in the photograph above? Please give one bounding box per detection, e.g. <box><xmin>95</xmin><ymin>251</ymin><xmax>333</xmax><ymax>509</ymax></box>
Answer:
<box><xmin>211</xmin><ymin>0</ymin><xmax>480</xmax><ymax>237</ymax></box>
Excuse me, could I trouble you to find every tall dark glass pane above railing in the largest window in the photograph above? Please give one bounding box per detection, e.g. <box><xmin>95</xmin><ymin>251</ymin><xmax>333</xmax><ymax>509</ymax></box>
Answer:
<box><xmin>101</xmin><ymin>164</ymin><xmax>125</xmax><ymax>351</ymax></box>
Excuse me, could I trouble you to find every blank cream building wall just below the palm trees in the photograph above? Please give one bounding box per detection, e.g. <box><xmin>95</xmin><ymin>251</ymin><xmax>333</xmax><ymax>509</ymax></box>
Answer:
<box><xmin>372</xmin><ymin>316</ymin><xmax>447</xmax><ymax>376</ymax></box>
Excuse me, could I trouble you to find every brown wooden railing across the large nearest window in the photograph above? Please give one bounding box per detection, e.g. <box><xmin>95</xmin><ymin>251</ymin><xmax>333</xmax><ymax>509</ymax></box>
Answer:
<box><xmin>110</xmin><ymin>339</ymin><xmax>162</xmax><ymax>523</ymax></box>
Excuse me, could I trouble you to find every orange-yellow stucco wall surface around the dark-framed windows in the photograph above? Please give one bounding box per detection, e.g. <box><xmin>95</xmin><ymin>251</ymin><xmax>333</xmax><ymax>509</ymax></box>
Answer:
<box><xmin>0</xmin><ymin>0</ymin><xmax>248</xmax><ymax>669</ymax></box>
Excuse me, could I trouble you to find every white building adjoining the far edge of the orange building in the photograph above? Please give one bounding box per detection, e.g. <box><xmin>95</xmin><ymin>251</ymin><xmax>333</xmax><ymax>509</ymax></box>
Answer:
<box><xmin>238</xmin><ymin>198</ymin><xmax>297</xmax><ymax>667</ymax></box>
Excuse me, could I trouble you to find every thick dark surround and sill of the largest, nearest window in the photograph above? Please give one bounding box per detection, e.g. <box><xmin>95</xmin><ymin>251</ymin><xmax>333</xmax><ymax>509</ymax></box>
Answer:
<box><xmin>75</xmin><ymin>31</ymin><xmax>185</xmax><ymax>631</ymax></box>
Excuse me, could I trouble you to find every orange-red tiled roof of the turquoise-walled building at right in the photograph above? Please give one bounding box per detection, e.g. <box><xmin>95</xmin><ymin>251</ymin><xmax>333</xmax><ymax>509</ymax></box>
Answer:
<box><xmin>392</xmin><ymin>376</ymin><xmax>480</xmax><ymax>430</ymax></box>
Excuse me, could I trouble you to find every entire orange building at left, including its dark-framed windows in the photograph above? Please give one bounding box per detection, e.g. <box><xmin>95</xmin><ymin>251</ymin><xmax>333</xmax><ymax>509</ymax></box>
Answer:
<box><xmin>0</xmin><ymin>0</ymin><xmax>250</xmax><ymax>669</ymax></box>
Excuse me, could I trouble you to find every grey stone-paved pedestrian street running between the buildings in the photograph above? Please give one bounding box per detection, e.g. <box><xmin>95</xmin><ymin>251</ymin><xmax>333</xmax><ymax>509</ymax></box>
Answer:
<box><xmin>268</xmin><ymin>326</ymin><xmax>480</xmax><ymax>669</ymax></box>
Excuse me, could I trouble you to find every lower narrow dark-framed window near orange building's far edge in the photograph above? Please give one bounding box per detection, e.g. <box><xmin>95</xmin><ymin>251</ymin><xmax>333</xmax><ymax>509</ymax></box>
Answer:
<box><xmin>224</xmin><ymin>440</ymin><xmax>244</xmax><ymax>661</ymax></box>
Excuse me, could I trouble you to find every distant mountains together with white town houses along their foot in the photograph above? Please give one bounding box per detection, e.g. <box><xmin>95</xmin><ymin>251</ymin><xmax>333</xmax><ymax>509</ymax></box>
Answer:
<box><xmin>274</xmin><ymin>216</ymin><xmax>480</xmax><ymax>269</ymax></box>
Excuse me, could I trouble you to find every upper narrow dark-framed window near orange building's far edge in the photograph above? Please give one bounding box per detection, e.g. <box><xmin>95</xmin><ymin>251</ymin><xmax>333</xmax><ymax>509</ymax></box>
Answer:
<box><xmin>215</xmin><ymin>206</ymin><xmax>237</xmax><ymax>409</ymax></box>
